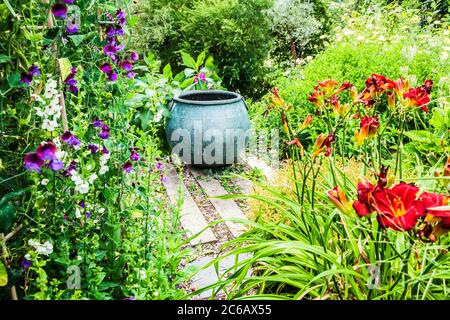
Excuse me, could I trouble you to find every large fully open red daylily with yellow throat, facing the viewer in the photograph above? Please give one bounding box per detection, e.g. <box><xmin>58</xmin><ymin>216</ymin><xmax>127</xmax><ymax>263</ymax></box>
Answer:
<box><xmin>370</xmin><ymin>182</ymin><xmax>425</xmax><ymax>231</ymax></box>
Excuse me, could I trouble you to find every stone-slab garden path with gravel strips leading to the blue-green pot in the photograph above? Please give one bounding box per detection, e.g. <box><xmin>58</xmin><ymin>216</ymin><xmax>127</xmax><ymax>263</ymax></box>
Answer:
<box><xmin>164</xmin><ymin>156</ymin><xmax>274</xmax><ymax>299</ymax></box>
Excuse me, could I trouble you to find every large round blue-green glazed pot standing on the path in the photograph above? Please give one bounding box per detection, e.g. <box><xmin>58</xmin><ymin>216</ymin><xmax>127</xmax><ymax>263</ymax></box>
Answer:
<box><xmin>166</xmin><ymin>90</ymin><xmax>250</xmax><ymax>167</ymax></box>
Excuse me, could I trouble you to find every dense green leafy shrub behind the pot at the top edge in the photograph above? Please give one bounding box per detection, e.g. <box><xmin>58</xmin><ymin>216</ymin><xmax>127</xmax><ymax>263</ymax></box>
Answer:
<box><xmin>130</xmin><ymin>0</ymin><xmax>272</xmax><ymax>95</ymax></box>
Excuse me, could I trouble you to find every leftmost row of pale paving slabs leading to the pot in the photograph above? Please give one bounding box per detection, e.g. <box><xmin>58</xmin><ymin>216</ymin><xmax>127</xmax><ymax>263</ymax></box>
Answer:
<box><xmin>164</xmin><ymin>166</ymin><xmax>217</xmax><ymax>245</ymax></box>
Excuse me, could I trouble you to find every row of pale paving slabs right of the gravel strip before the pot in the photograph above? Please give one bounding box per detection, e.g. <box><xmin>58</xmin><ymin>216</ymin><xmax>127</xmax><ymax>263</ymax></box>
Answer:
<box><xmin>189</xmin><ymin>167</ymin><xmax>247</xmax><ymax>237</ymax></box>
